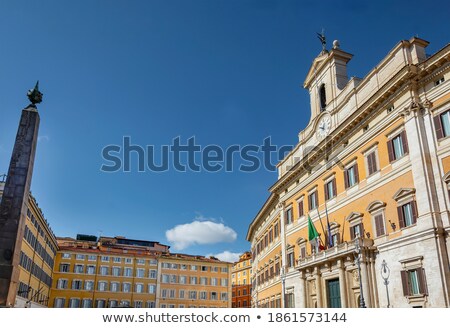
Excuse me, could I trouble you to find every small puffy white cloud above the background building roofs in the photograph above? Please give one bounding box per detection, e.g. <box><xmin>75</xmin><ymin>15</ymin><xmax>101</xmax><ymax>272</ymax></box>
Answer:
<box><xmin>166</xmin><ymin>221</ymin><xmax>237</xmax><ymax>250</ymax></box>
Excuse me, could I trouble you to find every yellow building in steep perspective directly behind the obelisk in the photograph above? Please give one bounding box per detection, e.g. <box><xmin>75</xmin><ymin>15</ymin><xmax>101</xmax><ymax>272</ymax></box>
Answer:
<box><xmin>0</xmin><ymin>182</ymin><xmax>58</xmax><ymax>308</ymax></box>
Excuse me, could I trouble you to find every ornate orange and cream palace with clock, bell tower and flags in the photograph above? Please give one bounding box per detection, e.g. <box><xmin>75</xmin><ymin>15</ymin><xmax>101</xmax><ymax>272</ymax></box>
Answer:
<box><xmin>247</xmin><ymin>38</ymin><xmax>450</xmax><ymax>307</ymax></box>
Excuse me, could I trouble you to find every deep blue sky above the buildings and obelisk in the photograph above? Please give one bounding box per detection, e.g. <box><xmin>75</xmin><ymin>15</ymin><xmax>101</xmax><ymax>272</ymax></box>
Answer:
<box><xmin>0</xmin><ymin>0</ymin><xmax>450</xmax><ymax>258</ymax></box>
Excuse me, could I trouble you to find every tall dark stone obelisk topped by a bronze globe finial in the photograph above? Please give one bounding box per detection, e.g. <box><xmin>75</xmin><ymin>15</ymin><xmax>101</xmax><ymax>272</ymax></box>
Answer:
<box><xmin>0</xmin><ymin>81</ymin><xmax>42</xmax><ymax>307</ymax></box>
